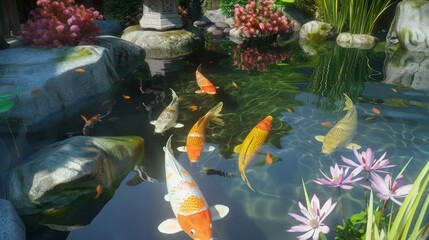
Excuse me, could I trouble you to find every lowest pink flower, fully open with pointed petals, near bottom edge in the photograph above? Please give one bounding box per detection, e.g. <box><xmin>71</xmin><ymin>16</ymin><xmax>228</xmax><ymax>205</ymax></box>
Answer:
<box><xmin>287</xmin><ymin>195</ymin><xmax>337</xmax><ymax>240</ymax></box>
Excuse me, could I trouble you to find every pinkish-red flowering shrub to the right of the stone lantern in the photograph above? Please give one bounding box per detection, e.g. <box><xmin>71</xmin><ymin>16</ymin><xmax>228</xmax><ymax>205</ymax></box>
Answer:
<box><xmin>234</xmin><ymin>0</ymin><xmax>295</xmax><ymax>37</ymax></box>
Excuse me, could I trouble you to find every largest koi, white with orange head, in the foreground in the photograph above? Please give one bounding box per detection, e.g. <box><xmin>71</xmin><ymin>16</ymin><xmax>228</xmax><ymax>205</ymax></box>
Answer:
<box><xmin>158</xmin><ymin>136</ymin><xmax>229</xmax><ymax>240</ymax></box>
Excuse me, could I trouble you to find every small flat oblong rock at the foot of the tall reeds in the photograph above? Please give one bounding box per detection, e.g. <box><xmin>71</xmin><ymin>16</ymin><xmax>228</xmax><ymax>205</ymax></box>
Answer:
<box><xmin>336</xmin><ymin>33</ymin><xmax>377</xmax><ymax>49</ymax></box>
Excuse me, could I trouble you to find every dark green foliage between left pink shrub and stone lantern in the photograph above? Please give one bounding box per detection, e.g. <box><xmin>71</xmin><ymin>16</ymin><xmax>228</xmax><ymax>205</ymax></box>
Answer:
<box><xmin>103</xmin><ymin>0</ymin><xmax>143</xmax><ymax>24</ymax></box>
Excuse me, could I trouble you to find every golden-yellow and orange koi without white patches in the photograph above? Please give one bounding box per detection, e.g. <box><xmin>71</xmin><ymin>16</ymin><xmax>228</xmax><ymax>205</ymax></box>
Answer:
<box><xmin>234</xmin><ymin>116</ymin><xmax>273</xmax><ymax>191</ymax></box>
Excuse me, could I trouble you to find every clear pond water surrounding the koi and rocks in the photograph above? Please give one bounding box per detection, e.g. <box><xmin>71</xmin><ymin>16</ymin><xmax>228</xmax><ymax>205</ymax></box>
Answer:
<box><xmin>5</xmin><ymin>36</ymin><xmax>429</xmax><ymax>240</ymax></box>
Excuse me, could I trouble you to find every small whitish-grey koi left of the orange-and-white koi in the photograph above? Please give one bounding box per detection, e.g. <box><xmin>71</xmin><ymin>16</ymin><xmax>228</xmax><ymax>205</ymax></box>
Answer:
<box><xmin>150</xmin><ymin>88</ymin><xmax>183</xmax><ymax>133</ymax></box>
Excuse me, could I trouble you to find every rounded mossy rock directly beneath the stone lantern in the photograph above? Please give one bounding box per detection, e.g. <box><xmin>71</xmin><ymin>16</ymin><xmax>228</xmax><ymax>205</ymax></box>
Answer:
<box><xmin>121</xmin><ymin>25</ymin><xmax>203</xmax><ymax>59</ymax></box>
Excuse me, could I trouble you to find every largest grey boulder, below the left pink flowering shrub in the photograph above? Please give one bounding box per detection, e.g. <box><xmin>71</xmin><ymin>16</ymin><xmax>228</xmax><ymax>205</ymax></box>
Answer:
<box><xmin>0</xmin><ymin>37</ymin><xmax>144</xmax><ymax>126</ymax></box>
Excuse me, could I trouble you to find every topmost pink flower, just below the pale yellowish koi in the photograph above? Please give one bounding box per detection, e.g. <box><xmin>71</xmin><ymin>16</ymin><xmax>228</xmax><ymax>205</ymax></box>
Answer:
<box><xmin>341</xmin><ymin>148</ymin><xmax>395</xmax><ymax>173</ymax></box>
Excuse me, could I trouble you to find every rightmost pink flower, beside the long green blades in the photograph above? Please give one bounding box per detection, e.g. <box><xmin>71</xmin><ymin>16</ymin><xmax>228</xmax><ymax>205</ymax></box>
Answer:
<box><xmin>364</xmin><ymin>173</ymin><xmax>413</xmax><ymax>206</ymax></box>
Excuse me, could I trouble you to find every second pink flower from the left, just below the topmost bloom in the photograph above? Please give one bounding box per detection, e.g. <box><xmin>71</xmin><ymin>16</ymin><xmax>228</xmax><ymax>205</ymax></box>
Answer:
<box><xmin>313</xmin><ymin>163</ymin><xmax>363</xmax><ymax>189</ymax></box>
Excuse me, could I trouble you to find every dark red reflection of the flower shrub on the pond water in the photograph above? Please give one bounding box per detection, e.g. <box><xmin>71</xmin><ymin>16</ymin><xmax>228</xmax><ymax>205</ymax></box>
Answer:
<box><xmin>233</xmin><ymin>45</ymin><xmax>290</xmax><ymax>72</ymax></box>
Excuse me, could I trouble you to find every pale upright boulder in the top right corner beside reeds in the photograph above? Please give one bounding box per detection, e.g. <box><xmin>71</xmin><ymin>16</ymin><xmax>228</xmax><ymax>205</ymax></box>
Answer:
<box><xmin>386</xmin><ymin>0</ymin><xmax>429</xmax><ymax>51</ymax></box>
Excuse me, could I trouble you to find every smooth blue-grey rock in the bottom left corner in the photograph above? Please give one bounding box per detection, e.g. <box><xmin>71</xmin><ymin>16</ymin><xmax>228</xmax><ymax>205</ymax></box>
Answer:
<box><xmin>0</xmin><ymin>198</ymin><xmax>26</xmax><ymax>240</ymax></box>
